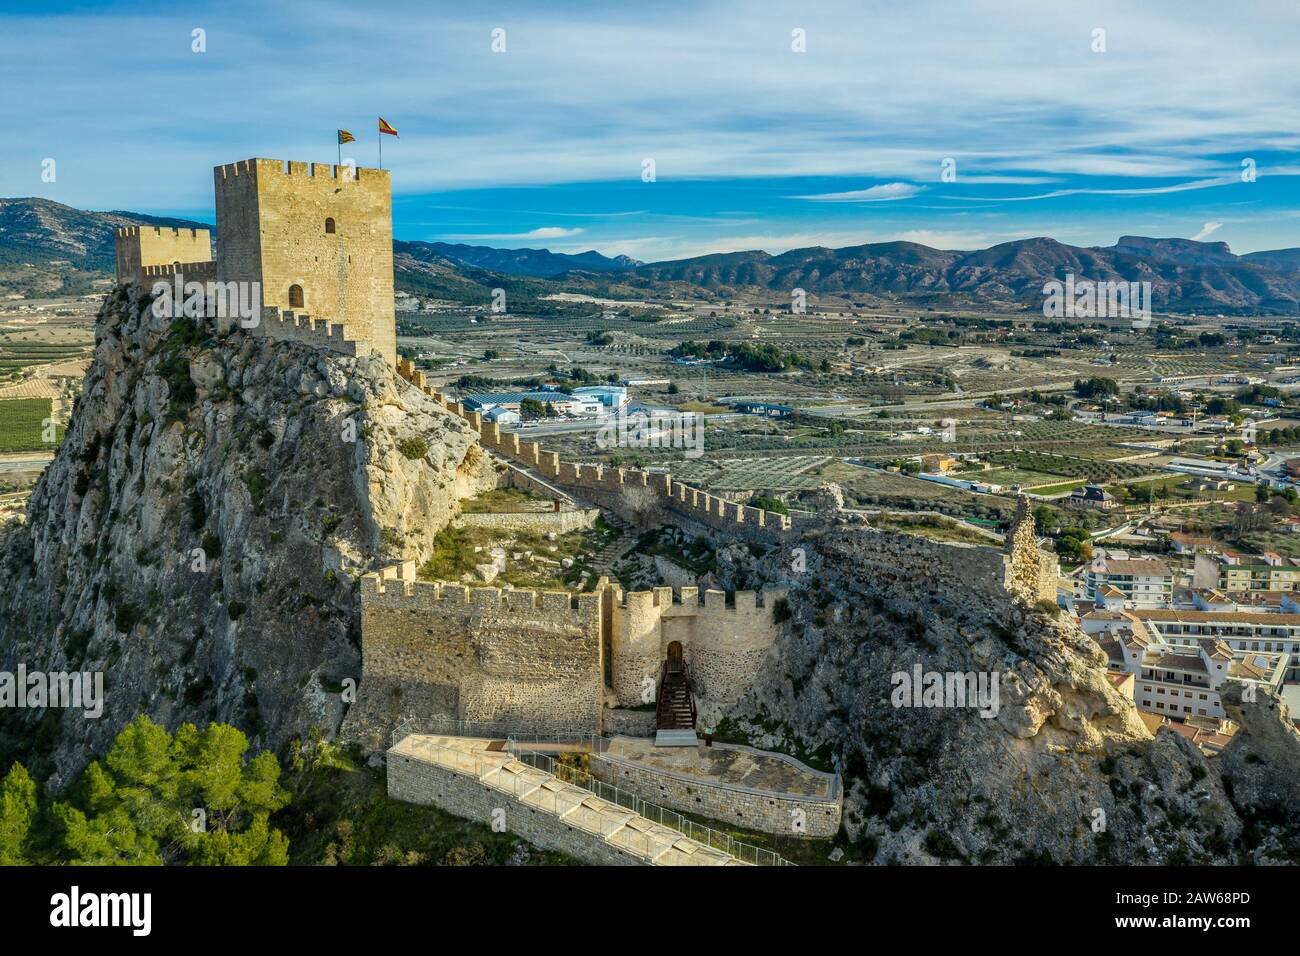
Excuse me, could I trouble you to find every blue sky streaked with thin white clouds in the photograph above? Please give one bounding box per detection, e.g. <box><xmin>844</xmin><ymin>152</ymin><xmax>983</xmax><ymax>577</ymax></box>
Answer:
<box><xmin>0</xmin><ymin>0</ymin><xmax>1300</xmax><ymax>260</ymax></box>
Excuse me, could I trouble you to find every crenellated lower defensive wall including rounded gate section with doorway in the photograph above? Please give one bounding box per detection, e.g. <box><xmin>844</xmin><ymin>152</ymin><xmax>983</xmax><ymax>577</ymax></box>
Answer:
<box><xmin>346</xmin><ymin>562</ymin><xmax>780</xmax><ymax>745</ymax></box>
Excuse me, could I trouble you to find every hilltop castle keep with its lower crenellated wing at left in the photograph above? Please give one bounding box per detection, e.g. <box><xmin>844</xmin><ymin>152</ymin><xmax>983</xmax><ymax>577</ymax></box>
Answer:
<box><xmin>117</xmin><ymin>159</ymin><xmax>397</xmax><ymax>364</ymax></box>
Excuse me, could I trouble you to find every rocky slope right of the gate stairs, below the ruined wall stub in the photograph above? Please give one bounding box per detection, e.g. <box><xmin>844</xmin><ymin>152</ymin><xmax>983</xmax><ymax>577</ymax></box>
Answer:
<box><xmin>719</xmin><ymin>528</ymin><xmax>1300</xmax><ymax>864</ymax></box>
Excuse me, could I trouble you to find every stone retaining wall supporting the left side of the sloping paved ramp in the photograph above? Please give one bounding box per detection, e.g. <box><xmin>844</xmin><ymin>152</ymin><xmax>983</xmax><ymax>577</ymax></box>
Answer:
<box><xmin>387</xmin><ymin>753</ymin><xmax>644</xmax><ymax>866</ymax></box>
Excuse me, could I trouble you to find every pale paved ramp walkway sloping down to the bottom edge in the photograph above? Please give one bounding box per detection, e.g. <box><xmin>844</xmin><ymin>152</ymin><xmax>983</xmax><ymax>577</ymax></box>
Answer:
<box><xmin>390</xmin><ymin>734</ymin><xmax>749</xmax><ymax>866</ymax></box>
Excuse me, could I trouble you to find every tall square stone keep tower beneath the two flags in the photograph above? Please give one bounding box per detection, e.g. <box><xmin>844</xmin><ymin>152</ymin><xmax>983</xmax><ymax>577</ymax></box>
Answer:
<box><xmin>213</xmin><ymin>159</ymin><xmax>397</xmax><ymax>365</ymax></box>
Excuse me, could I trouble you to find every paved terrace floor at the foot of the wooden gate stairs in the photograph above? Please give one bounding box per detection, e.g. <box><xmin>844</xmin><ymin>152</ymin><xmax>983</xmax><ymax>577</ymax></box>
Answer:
<box><xmin>601</xmin><ymin>736</ymin><xmax>839</xmax><ymax>800</ymax></box>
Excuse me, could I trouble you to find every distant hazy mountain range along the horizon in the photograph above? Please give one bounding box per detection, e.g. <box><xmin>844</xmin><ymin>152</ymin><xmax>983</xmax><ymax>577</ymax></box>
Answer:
<box><xmin>0</xmin><ymin>199</ymin><xmax>1300</xmax><ymax>315</ymax></box>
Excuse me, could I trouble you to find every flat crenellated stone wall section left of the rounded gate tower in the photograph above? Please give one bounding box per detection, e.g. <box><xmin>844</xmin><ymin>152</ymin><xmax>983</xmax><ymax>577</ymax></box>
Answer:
<box><xmin>348</xmin><ymin>562</ymin><xmax>603</xmax><ymax>744</ymax></box>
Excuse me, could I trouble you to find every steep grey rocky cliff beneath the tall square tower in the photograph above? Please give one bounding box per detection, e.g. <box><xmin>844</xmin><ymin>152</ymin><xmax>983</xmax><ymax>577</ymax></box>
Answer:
<box><xmin>0</xmin><ymin>287</ymin><xmax>495</xmax><ymax>786</ymax></box>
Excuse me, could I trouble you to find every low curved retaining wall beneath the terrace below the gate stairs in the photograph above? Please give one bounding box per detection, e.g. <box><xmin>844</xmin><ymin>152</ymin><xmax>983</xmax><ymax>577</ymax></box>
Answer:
<box><xmin>590</xmin><ymin>744</ymin><xmax>844</xmax><ymax>839</ymax></box>
